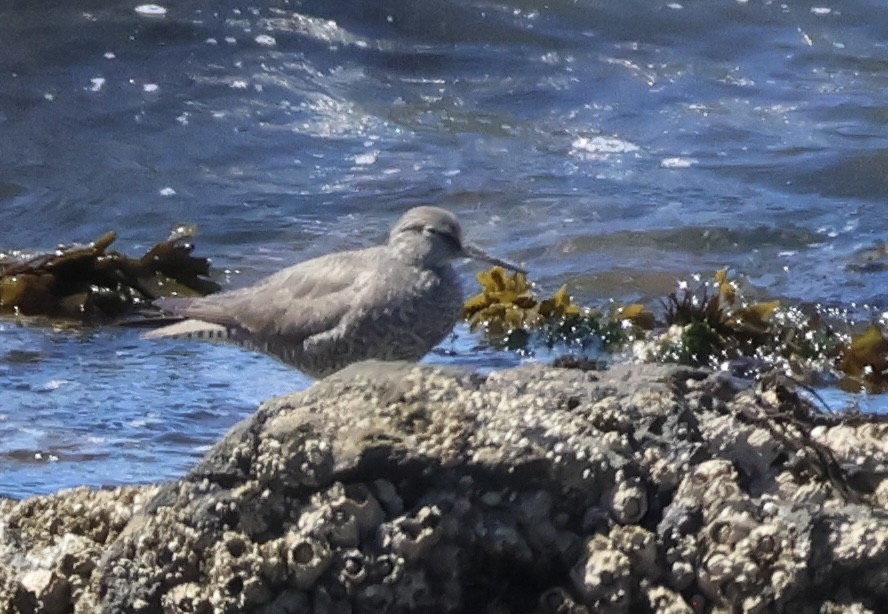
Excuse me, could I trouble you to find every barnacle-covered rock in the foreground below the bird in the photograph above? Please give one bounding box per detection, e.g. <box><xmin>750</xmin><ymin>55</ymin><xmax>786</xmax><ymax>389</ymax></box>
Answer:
<box><xmin>0</xmin><ymin>363</ymin><xmax>888</xmax><ymax>613</ymax></box>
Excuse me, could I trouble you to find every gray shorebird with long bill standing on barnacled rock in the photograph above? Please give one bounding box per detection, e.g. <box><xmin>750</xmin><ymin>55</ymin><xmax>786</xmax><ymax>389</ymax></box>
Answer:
<box><xmin>145</xmin><ymin>207</ymin><xmax>524</xmax><ymax>378</ymax></box>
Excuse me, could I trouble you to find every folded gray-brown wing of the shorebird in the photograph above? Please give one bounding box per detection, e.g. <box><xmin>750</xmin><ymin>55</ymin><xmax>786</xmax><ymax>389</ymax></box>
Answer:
<box><xmin>157</xmin><ymin>248</ymin><xmax>381</xmax><ymax>339</ymax></box>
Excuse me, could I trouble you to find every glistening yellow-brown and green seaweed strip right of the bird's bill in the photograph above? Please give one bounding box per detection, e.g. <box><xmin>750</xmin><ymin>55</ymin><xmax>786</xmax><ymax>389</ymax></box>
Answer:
<box><xmin>463</xmin><ymin>267</ymin><xmax>888</xmax><ymax>393</ymax></box>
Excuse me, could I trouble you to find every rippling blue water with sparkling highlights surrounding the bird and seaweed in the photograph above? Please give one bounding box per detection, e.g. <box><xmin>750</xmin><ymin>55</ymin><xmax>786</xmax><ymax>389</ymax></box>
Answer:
<box><xmin>0</xmin><ymin>0</ymin><xmax>888</xmax><ymax>496</ymax></box>
